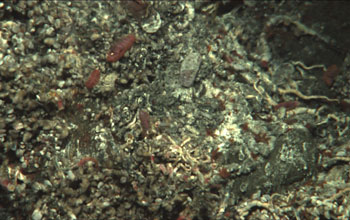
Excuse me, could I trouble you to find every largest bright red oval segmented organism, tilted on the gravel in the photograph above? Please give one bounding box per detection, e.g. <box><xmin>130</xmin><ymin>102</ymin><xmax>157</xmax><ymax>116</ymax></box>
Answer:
<box><xmin>107</xmin><ymin>34</ymin><xmax>136</xmax><ymax>63</ymax></box>
